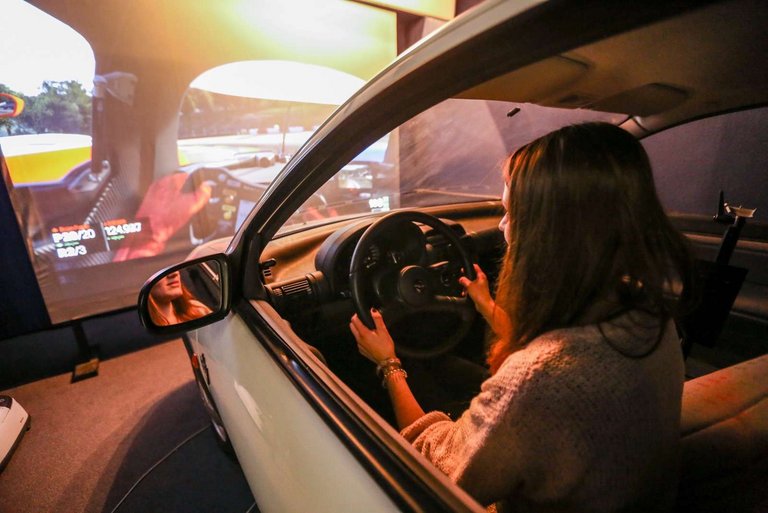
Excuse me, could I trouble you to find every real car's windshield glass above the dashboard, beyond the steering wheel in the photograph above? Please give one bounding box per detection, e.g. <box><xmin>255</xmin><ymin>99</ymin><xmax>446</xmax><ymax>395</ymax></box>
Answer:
<box><xmin>281</xmin><ymin>99</ymin><xmax>626</xmax><ymax>231</ymax></box>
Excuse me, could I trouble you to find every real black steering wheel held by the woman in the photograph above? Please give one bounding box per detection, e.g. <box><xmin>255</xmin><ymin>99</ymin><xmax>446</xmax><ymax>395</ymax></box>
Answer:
<box><xmin>349</xmin><ymin>210</ymin><xmax>475</xmax><ymax>358</ymax></box>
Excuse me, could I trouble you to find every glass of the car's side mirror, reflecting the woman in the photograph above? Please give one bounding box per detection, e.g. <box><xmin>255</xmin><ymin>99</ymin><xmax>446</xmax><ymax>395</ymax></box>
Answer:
<box><xmin>147</xmin><ymin>261</ymin><xmax>221</xmax><ymax>326</ymax></box>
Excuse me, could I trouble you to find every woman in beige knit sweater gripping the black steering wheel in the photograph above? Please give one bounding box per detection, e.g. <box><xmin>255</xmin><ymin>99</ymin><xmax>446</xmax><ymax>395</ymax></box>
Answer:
<box><xmin>350</xmin><ymin>123</ymin><xmax>690</xmax><ymax>512</ymax></box>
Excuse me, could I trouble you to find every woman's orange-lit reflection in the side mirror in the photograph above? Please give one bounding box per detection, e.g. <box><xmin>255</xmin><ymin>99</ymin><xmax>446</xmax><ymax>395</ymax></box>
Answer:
<box><xmin>149</xmin><ymin>271</ymin><xmax>211</xmax><ymax>326</ymax></box>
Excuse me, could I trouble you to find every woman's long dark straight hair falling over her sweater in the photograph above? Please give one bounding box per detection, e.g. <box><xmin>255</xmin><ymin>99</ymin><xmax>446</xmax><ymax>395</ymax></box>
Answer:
<box><xmin>488</xmin><ymin>123</ymin><xmax>691</xmax><ymax>372</ymax></box>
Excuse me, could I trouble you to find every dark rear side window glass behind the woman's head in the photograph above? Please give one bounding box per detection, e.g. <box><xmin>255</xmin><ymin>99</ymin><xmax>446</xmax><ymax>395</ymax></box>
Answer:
<box><xmin>643</xmin><ymin>107</ymin><xmax>768</xmax><ymax>221</ymax></box>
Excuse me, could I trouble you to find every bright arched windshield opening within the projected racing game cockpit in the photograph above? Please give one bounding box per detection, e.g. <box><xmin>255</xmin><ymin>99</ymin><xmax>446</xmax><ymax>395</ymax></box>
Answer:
<box><xmin>178</xmin><ymin>60</ymin><xmax>364</xmax><ymax>172</ymax></box>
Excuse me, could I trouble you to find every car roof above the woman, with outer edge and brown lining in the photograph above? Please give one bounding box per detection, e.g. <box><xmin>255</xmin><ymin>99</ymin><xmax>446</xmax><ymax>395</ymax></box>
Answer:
<box><xmin>292</xmin><ymin>0</ymin><xmax>768</xmax><ymax>154</ymax></box>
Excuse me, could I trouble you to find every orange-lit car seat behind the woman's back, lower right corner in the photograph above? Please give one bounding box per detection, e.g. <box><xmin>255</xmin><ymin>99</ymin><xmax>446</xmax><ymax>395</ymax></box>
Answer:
<box><xmin>678</xmin><ymin>355</ymin><xmax>768</xmax><ymax>513</ymax></box>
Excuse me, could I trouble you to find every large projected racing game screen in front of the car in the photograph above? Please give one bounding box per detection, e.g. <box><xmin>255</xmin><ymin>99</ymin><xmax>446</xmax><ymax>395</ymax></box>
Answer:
<box><xmin>0</xmin><ymin>0</ymin><xmax>397</xmax><ymax>324</ymax></box>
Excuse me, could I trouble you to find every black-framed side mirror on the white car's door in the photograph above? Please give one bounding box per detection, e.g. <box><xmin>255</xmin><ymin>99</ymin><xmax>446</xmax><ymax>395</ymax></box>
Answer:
<box><xmin>139</xmin><ymin>254</ymin><xmax>230</xmax><ymax>333</ymax></box>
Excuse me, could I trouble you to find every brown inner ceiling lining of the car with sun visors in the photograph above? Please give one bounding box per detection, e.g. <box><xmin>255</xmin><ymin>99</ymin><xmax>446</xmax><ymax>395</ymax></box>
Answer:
<box><xmin>460</xmin><ymin>0</ymin><xmax>768</xmax><ymax>131</ymax></box>
